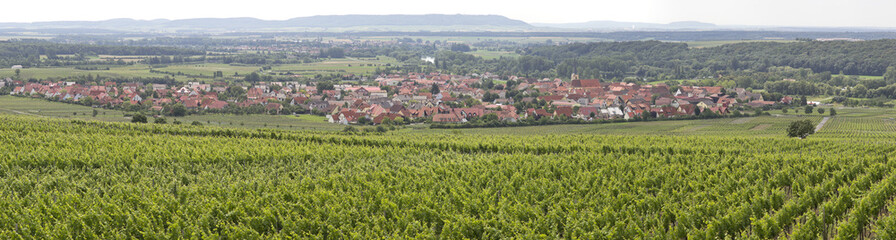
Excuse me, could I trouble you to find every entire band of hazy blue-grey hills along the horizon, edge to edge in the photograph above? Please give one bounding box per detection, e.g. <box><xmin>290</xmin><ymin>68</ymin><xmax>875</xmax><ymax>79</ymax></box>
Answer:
<box><xmin>0</xmin><ymin>14</ymin><xmax>896</xmax><ymax>34</ymax></box>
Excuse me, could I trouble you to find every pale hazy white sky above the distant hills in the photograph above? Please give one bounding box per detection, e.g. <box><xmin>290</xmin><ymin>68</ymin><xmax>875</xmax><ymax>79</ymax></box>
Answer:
<box><xmin>7</xmin><ymin>0</ymin><xmax>896</xmax><ymax>27</ymax></box>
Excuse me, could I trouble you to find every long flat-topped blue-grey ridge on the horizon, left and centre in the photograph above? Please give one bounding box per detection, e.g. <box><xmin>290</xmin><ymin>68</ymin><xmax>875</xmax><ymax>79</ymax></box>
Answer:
<box><xmin>0</xmin><ymin>14</ymin><xmax>532</xmax><ymax>32</ymax></box>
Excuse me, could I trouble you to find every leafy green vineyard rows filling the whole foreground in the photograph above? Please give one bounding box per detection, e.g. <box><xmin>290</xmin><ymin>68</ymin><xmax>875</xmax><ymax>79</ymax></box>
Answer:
<box><xmin>0</xmin><ymin>110</ymin><xmax>896</xmax><ymax>239</ymax></box>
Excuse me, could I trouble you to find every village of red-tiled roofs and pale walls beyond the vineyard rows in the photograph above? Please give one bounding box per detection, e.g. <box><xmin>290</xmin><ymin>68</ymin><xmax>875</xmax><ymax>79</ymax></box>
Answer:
<box><xmin>0</xmin><ymin>73</ymin><xmax>793</xmax><ymax>125</ymax></box>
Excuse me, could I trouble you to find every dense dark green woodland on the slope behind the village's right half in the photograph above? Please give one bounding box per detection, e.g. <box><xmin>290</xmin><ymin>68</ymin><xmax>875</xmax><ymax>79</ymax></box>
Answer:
<box><xmin>430</xmin><ymin>40</ymin><xmax>896</xmax><ymax>80</ymax></box>
